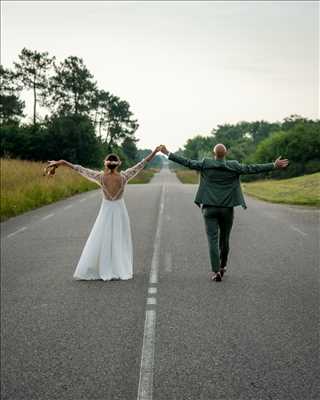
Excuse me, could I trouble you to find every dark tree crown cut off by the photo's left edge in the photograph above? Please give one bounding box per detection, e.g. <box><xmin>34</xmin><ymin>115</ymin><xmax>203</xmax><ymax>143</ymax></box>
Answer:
<box><xmin>0</xmin><ymin>65</ymin><xmax>25</xmax><ymax>124</ymax></box>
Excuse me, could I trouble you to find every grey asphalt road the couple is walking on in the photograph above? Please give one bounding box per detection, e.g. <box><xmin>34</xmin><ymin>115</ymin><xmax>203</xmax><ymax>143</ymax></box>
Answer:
<box><xmin>1</xmin><ymin>166</ymin><xmax>320</xmax><ymax>400</ymax></box>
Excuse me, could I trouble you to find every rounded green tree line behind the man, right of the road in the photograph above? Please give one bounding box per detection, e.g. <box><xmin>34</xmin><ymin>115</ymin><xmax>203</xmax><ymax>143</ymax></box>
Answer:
<box><xmin>178</xmin><ymin>115</ymin><xmax>320</xmax><ymax>180</ymax></box>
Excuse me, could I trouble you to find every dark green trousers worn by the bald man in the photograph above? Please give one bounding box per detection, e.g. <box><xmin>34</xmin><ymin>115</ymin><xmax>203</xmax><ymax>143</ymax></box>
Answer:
<box><xmin>202</xmin><ymin>205</ymin><xmax>234</xmax><ymax>272</ymax></box>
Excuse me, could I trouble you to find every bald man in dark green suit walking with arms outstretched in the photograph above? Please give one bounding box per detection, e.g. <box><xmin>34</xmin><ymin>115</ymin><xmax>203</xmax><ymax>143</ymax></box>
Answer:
<box><xmin>160</xmin><ymin>144</ymin><xmax>288</xmax><ymax>281</ymax></box>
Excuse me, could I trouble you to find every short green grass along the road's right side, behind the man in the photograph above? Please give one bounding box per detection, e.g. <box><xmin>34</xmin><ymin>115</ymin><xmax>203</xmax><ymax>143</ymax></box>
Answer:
<box><xmin>175</xmin><ymin>170</ymin><xmax>320</xmax><ymax>207</ymax></box>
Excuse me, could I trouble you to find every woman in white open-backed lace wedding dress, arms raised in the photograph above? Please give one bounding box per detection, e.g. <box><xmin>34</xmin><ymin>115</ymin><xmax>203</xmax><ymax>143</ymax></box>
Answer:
<box><xmin>47</xmin><ymin>146</ymin><xmax>160</xmax><ymax>281</ymax></box>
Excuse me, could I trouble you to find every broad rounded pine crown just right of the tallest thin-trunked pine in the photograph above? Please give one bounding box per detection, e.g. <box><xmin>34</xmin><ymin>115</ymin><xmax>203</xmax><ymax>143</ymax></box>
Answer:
<box><xmin>48</xmin><ymin>56</ymin><xmax>96</xmax><ymax>115</ymax></box>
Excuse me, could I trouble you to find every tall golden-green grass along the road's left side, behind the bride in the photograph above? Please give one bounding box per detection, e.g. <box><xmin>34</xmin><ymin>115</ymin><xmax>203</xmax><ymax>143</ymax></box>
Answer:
<box><xmin>0</xmin><ymin>158</ymin><xmax>156</xmax><ymax>222</ymax></box>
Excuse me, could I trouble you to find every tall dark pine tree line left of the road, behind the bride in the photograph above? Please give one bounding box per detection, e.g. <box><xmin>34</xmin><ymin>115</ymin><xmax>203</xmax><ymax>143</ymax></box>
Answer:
<box><xmin>0</xmin><ymin>48</ymin><xmax>160</xmax><ymax>167</ymax></box>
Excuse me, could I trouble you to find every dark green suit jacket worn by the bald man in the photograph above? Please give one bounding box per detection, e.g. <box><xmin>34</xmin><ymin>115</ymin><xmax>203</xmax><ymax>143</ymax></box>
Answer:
<box><xmin>169</xmin><ymin>153</ymin><xmax>275</xmax><ymax>208</ymax></box>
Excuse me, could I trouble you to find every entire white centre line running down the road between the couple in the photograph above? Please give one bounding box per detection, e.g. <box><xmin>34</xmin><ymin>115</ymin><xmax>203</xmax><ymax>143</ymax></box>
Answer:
<box><xmin>137</xmin><ymin>185</ymin><xmax>165</xmax><ymax>400</ymax></box>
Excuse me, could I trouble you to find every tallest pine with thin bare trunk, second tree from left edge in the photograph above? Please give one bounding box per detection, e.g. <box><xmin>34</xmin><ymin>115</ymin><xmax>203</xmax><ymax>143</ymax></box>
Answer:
<box><xmin>14</xmin><ymin>48</ymin><xmax>54</xmax><ymax>125</ymax></box>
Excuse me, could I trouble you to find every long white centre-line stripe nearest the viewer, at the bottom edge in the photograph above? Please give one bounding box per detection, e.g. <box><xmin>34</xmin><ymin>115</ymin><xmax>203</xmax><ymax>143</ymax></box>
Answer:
<box><xmin>138</xmin><ymin>310</ymin><xmax>156</xmax><ymax>400</ymax></box>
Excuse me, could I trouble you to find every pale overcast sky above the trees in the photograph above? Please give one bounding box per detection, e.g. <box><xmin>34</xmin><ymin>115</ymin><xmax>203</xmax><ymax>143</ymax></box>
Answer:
<box><xmin>1</xmin><ymin>1</ymin><xmax>319</xmax><ymax>150</ymax></box>
